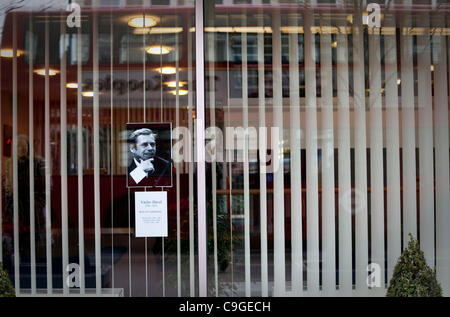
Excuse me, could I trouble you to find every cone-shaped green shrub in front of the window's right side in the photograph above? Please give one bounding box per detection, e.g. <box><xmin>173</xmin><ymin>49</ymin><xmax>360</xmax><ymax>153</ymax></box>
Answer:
<box><xmin>386</xmin><ymin>234</ymin><xmax>442</xmax><ymax>297</ymax></box>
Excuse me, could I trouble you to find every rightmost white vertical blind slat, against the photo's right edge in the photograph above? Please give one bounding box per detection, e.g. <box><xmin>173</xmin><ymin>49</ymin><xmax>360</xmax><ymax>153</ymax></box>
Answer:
<box><xmin>433</xmin><ymin>27</ymin><xmax>450</xmax><ymax>296</ymax></box>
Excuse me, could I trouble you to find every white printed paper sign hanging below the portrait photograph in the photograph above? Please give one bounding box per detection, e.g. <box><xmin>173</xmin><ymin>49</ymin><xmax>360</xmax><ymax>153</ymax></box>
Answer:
<box><xmin>134</xmin><ymin>191</ymin><xmax>167</xmax><ymax>237</ymax></box>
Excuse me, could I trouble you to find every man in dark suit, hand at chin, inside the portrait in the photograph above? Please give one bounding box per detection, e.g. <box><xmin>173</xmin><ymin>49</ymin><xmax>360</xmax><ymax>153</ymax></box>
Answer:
<box><xmin>128</xmin><ymin>128</ymin><xmax>172</xmax><ymax>187</ymax></box>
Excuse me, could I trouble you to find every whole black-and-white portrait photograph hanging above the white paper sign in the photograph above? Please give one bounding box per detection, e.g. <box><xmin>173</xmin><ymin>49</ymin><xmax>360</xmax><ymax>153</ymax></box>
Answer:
<box><xmin>126</xmin><ymin>122</ymin><xmax>173</xmax><ymax>188</ymax></box>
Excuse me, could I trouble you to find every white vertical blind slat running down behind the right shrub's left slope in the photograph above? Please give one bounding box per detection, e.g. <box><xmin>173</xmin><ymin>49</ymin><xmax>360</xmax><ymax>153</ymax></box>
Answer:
<box><xmin>384</xmin><ymin>24</ymin><xmax>401</xmax><ymax>281</ymax></box>
